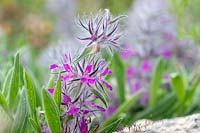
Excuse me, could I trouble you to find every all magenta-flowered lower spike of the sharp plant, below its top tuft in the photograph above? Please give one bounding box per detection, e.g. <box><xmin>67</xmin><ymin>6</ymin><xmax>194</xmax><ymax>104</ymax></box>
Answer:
<box><xmin>48</xmin><ymin>55</ymin><xmax>112</xmax><ymax>133</ymax></box>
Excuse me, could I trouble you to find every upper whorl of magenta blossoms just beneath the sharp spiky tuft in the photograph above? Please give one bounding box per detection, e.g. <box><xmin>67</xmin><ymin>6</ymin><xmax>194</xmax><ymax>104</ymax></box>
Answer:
<box><xmin>50</xmin><ymin>56</ymin><xmax>112</xmax><ymax>90</ymax></box>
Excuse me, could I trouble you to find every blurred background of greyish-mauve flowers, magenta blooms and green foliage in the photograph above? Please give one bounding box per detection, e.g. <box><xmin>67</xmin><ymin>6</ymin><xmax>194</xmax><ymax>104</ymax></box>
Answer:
<box><xmin>0</xmin><ymin>0</ymin><xmax>200</xmax><ymax>131</ymax></box>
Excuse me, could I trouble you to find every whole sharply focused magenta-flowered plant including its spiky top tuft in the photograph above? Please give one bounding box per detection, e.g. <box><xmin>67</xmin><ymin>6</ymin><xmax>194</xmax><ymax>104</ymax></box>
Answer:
<box><xmin>41</xmin><ymin>10</ymin><xmax>121</xmax><ymax>133</ymax></box>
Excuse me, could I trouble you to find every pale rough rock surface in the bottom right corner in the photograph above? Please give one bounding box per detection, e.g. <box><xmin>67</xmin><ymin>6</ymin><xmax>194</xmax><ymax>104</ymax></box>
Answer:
<box><xmin>116</xmin><ymin>114</ymin><xmax>200</xmax><ymax>133</ymax></box>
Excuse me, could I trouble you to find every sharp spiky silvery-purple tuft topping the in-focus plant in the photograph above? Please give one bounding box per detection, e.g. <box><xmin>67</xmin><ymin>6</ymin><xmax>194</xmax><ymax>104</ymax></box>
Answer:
<box><xmin>78</xmin><ymin>9</ymin><xmax>124</xmax><ymax>48</ymax></box>
